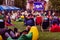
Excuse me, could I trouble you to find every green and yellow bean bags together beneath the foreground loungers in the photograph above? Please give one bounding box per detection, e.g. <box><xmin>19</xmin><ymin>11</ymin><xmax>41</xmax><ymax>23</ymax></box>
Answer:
<box><xmin>7</xmin><ymin>26</ymin><xmax>39</xmax><ymax>40</ymax></box>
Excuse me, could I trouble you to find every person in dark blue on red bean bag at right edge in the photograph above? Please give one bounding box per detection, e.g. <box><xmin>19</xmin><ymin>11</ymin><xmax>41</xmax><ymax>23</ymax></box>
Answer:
<box><xmin>49</xmin><ymin>17</ymin><xmax>60</xmax><ymax>32</ymax></box>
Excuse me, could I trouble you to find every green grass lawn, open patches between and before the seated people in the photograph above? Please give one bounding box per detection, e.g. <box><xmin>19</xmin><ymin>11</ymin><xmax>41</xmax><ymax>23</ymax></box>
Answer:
<box><xmin>9</xmin><ymin>22</ymin><xmax>60</xmax><ymax>40</ymax></box>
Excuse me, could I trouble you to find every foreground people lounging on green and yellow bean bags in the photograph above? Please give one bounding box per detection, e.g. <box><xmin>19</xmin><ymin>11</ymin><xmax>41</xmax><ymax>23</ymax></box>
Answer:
<box><xmin>0</xmin><ymin>26</ymin><xmax>39</xmax><ymax>40</ymax></box>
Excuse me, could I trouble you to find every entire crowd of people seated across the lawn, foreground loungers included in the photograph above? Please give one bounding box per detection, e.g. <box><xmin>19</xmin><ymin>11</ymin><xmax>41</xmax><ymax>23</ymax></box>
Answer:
<box><xmin>0</xmin><ymin>11</ymin><xmax>60</xmax><ymax>40</ymax></box>
